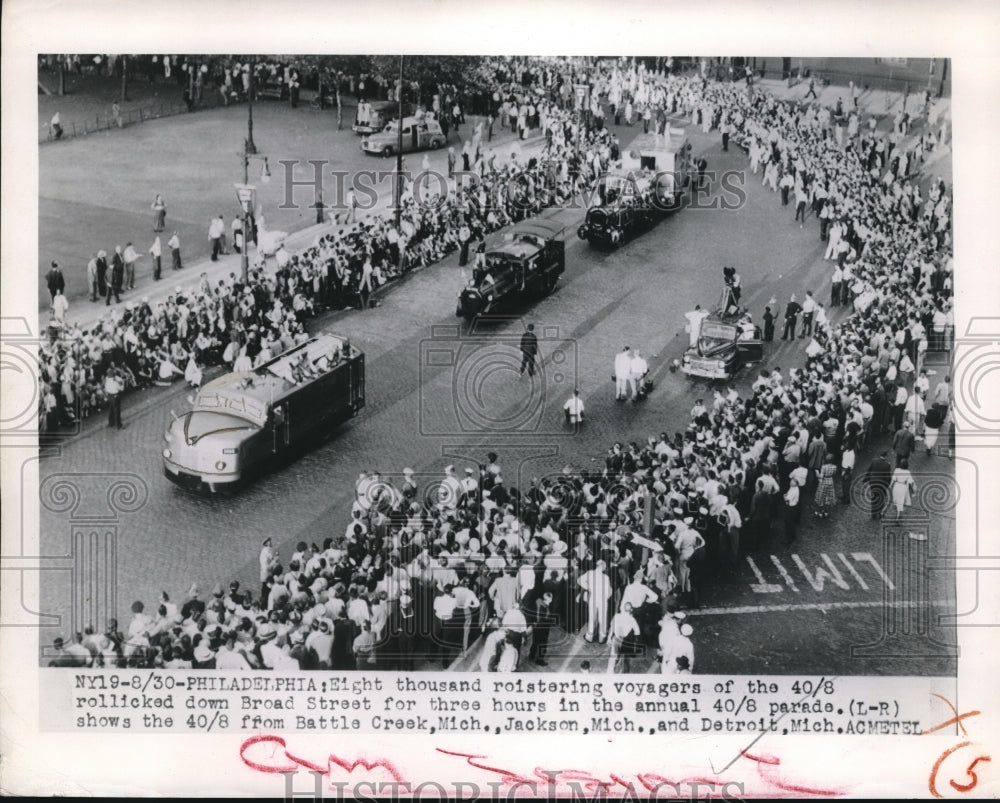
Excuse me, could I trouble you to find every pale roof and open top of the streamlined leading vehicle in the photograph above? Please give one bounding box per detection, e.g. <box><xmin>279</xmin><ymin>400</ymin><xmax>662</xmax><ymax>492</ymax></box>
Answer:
<box><xmin>194</xmin><ymin>332</ymin><xmax>361</xmax><ymax>426</ymax></box>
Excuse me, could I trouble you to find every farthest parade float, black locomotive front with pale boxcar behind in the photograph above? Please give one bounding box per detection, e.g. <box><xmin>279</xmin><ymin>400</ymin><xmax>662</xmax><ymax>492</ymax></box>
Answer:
<box><xmin>577</xmin><ymin>128</ymin><xmax>693</xmax><ymax>247</ymax></box>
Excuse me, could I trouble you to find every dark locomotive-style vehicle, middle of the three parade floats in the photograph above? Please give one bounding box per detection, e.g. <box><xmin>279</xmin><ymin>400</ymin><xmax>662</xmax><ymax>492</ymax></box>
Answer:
<box><xmin>455</xmin><ymin>219</ymin><xmax>566</xmax><ymax>321</ymax></box>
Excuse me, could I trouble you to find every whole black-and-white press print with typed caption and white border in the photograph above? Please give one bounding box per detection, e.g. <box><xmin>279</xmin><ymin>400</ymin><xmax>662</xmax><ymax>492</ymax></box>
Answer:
<box><xmin>3</xmin><ymin>4</ymin><xmax>1000</xmax><ymax>798</ymax></box>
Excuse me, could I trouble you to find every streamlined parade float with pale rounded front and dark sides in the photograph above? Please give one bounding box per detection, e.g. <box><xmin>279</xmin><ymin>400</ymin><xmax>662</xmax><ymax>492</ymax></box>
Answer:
<box><xmin>163</xmin><ymin>333</ymin><xmax>365</xmax><ymax>493</ymax></box>
